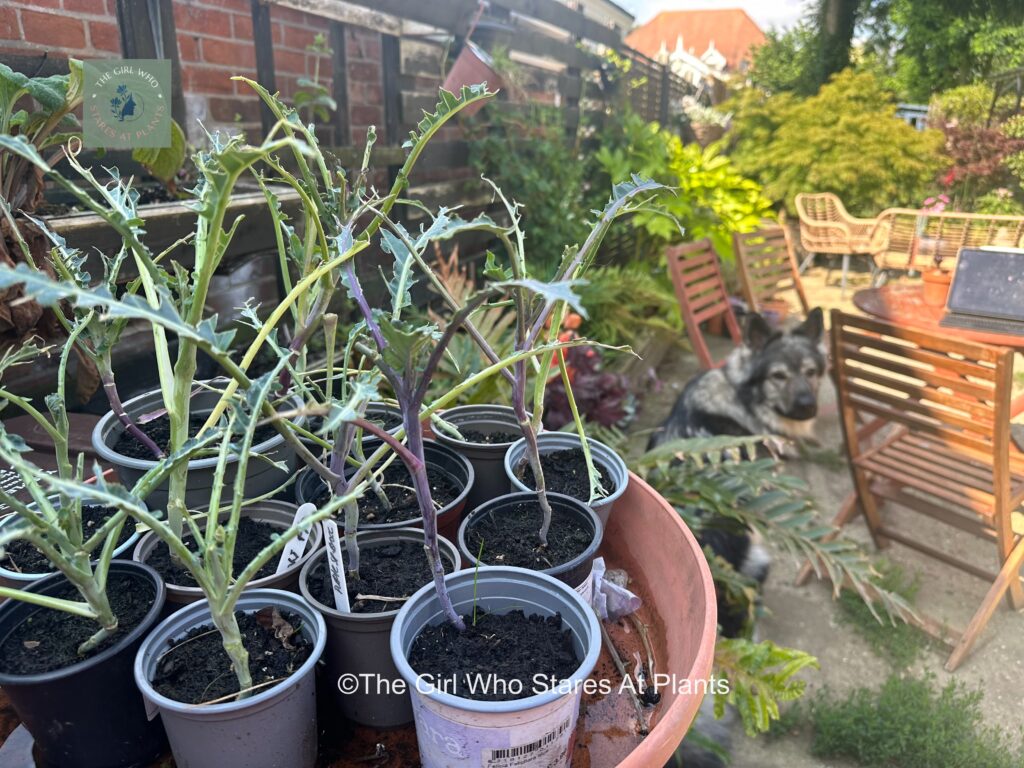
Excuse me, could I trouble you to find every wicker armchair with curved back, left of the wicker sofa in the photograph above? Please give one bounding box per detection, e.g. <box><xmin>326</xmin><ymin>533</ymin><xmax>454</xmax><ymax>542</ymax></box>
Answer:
<box><xmin>796</xmin><ymin>193</ymin><xmax>874</xmax><ymax>296</ymax></box>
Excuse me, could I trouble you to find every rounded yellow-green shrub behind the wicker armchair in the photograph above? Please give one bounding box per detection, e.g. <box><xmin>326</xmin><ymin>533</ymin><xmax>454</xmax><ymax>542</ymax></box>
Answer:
<box><xmin>728</xmin><ymin>70</ymin><xmax>946</xmax><ymax>216</ymax></box>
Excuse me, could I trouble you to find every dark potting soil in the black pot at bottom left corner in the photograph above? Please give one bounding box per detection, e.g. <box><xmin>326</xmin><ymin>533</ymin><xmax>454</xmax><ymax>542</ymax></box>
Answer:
<box><xmin>0</xmin><ymin>573</ymin><xmax>157</xmax><ymax>675</ymax></box>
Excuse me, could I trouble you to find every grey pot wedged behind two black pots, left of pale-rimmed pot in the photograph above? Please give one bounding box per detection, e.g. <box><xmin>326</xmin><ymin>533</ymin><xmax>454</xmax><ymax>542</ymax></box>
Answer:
<box><xmin>434</xmin><ymin>406</ymin><xmax>522</xmax><ymax>510</ymax></box>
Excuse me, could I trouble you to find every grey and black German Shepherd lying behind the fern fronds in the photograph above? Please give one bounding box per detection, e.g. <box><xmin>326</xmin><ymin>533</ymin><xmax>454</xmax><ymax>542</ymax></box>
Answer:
<box><xmin>648</xmin><ymin>308</ymin><xmax>825</xmax><ymax>768</ymax></box>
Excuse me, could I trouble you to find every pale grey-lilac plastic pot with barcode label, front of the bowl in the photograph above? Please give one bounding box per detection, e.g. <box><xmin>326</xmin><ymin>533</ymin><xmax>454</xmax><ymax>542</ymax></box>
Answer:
<box><xmin>391</xmin><ymin>566</ymin><xmax>601</xmax><ymax>768</ymax></box>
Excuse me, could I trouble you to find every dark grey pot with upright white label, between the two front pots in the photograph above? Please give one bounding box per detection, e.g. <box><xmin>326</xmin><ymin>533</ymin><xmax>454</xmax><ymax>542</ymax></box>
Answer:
<box><xmin>299</xmin><ymin>528</ymin><xmax>462</xmax><ymax>728</ymax></box>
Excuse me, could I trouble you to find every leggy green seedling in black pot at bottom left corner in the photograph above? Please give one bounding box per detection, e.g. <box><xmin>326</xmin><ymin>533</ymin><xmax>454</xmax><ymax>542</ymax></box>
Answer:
<box><xmin>0</xmin><ymin>342</ymin><xmax>174</xmax><ymax>768</ymax></box>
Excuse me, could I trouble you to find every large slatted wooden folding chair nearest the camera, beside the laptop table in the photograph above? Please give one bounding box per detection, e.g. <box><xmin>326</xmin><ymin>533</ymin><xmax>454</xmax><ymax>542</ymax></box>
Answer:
<box><xmin>831</xmin><ymin>309</ymin><xmax>1024</xmax><ymax>672</ymax></box>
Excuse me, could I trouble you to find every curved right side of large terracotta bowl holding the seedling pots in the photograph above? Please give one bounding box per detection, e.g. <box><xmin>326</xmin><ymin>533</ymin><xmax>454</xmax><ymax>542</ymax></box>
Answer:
<box><xmin>592</xmin><ymin>472</ymin><xmax>718</xmax><ymax>768</ymax></box>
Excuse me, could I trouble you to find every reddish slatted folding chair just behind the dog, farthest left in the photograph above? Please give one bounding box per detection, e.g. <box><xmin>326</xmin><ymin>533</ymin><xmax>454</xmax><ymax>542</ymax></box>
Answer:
<box><xmin>666</xmin><ymin>238</ymin><xmax>742</xmax><ymax>369</ymax></box>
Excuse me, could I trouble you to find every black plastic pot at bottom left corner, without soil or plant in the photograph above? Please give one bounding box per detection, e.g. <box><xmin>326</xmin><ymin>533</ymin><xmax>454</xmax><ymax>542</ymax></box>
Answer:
<box><xmin>0</xmin><ymin>560</ymin><xmax>167</xmax><ymax>768</ymax></box>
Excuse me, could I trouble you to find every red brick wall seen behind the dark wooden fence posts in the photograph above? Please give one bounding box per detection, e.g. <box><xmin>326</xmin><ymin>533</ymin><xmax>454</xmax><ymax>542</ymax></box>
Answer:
<box><xmin>0</xmin><ymin>0</ymin><xmax>384</xmax><ymax>143</ymax></box>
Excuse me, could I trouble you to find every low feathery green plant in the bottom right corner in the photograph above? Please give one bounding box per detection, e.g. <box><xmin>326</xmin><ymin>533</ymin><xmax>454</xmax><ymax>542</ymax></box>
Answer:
<box><xmin>811</xmin><ymin>675</ymin><xmax>1024</xmax><ymax>768</ymax></box>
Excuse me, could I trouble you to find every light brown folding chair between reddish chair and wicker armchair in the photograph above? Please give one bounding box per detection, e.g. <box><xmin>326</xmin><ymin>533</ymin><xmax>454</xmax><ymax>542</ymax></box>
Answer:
<box><xmin>732</xmin><ymin>224</ymin><xmax>810</xmax><ymax>316</ymax></box>
